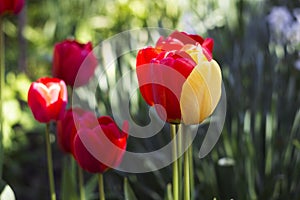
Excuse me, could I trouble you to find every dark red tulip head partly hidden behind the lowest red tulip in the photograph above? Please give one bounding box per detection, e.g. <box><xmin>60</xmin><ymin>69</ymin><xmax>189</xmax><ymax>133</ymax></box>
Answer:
<box><xmin>56</xmin><ymin>108</ymin><xmax>92</xmax><ymax>153</ymax></box>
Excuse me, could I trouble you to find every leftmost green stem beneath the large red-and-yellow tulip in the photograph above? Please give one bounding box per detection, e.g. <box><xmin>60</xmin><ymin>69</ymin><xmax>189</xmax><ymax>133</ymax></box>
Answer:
<box><xmin>170</xmin><ymin>124</ymin><xmax>179</xmax><ymax>200</ymax></box>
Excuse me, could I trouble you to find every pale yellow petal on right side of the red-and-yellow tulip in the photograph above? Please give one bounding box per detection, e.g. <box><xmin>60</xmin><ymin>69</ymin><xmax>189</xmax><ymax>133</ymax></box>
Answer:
<box><xmin>180</xmin><ymin>60</ymin><xmax>222</xmax><ymax>124</ymax></box>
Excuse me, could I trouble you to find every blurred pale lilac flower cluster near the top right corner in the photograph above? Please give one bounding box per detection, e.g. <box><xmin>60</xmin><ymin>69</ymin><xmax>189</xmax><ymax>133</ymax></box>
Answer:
<box><xmin>267</xmin><ymin>6</ymin><xmax>293</xmax><ymax>34</ymax></box>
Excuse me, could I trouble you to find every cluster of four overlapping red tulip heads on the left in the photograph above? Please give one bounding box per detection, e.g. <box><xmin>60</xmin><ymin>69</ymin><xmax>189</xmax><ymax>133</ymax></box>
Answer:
<box><xmin>28</xmin><ymin>40</ymin><xmax>128</xmax><ymax>198</ymax></box>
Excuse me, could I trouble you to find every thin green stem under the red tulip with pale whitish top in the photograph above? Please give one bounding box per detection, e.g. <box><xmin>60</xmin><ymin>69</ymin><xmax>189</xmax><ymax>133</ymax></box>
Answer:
<box><xmin>46</xmin><ymin>123</ymin><xmax>56</xmax><ymax>200</ymax></box>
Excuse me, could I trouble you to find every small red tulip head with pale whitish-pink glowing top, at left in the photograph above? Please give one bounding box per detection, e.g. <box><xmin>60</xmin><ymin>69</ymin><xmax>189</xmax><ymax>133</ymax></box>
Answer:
<box><xmin>28</xmin><ymin>77</ymin><xmax>68</xmax><ymax>123</ymax></box>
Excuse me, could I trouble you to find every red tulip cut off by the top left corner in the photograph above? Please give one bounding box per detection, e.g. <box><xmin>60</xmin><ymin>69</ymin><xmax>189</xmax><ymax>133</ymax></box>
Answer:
<box><xmin>0</xmin><ymin>0</ymin><xmax>25</xmax><ymax>15</ymax></box>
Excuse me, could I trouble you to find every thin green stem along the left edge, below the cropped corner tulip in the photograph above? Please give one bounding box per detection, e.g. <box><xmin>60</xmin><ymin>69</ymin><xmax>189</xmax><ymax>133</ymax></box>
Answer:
<box><xmin>0</xmin><ymin>16</ymin><xmax>5</xmax><ymax>180</ymax></box>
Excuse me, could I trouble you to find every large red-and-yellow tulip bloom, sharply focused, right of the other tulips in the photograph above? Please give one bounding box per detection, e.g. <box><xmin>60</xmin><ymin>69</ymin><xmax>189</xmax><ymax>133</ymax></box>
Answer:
<box><xmin>136</xmin><ymin>31</ymin><xmax>222</xmax><ymax>124</ymax></box>
